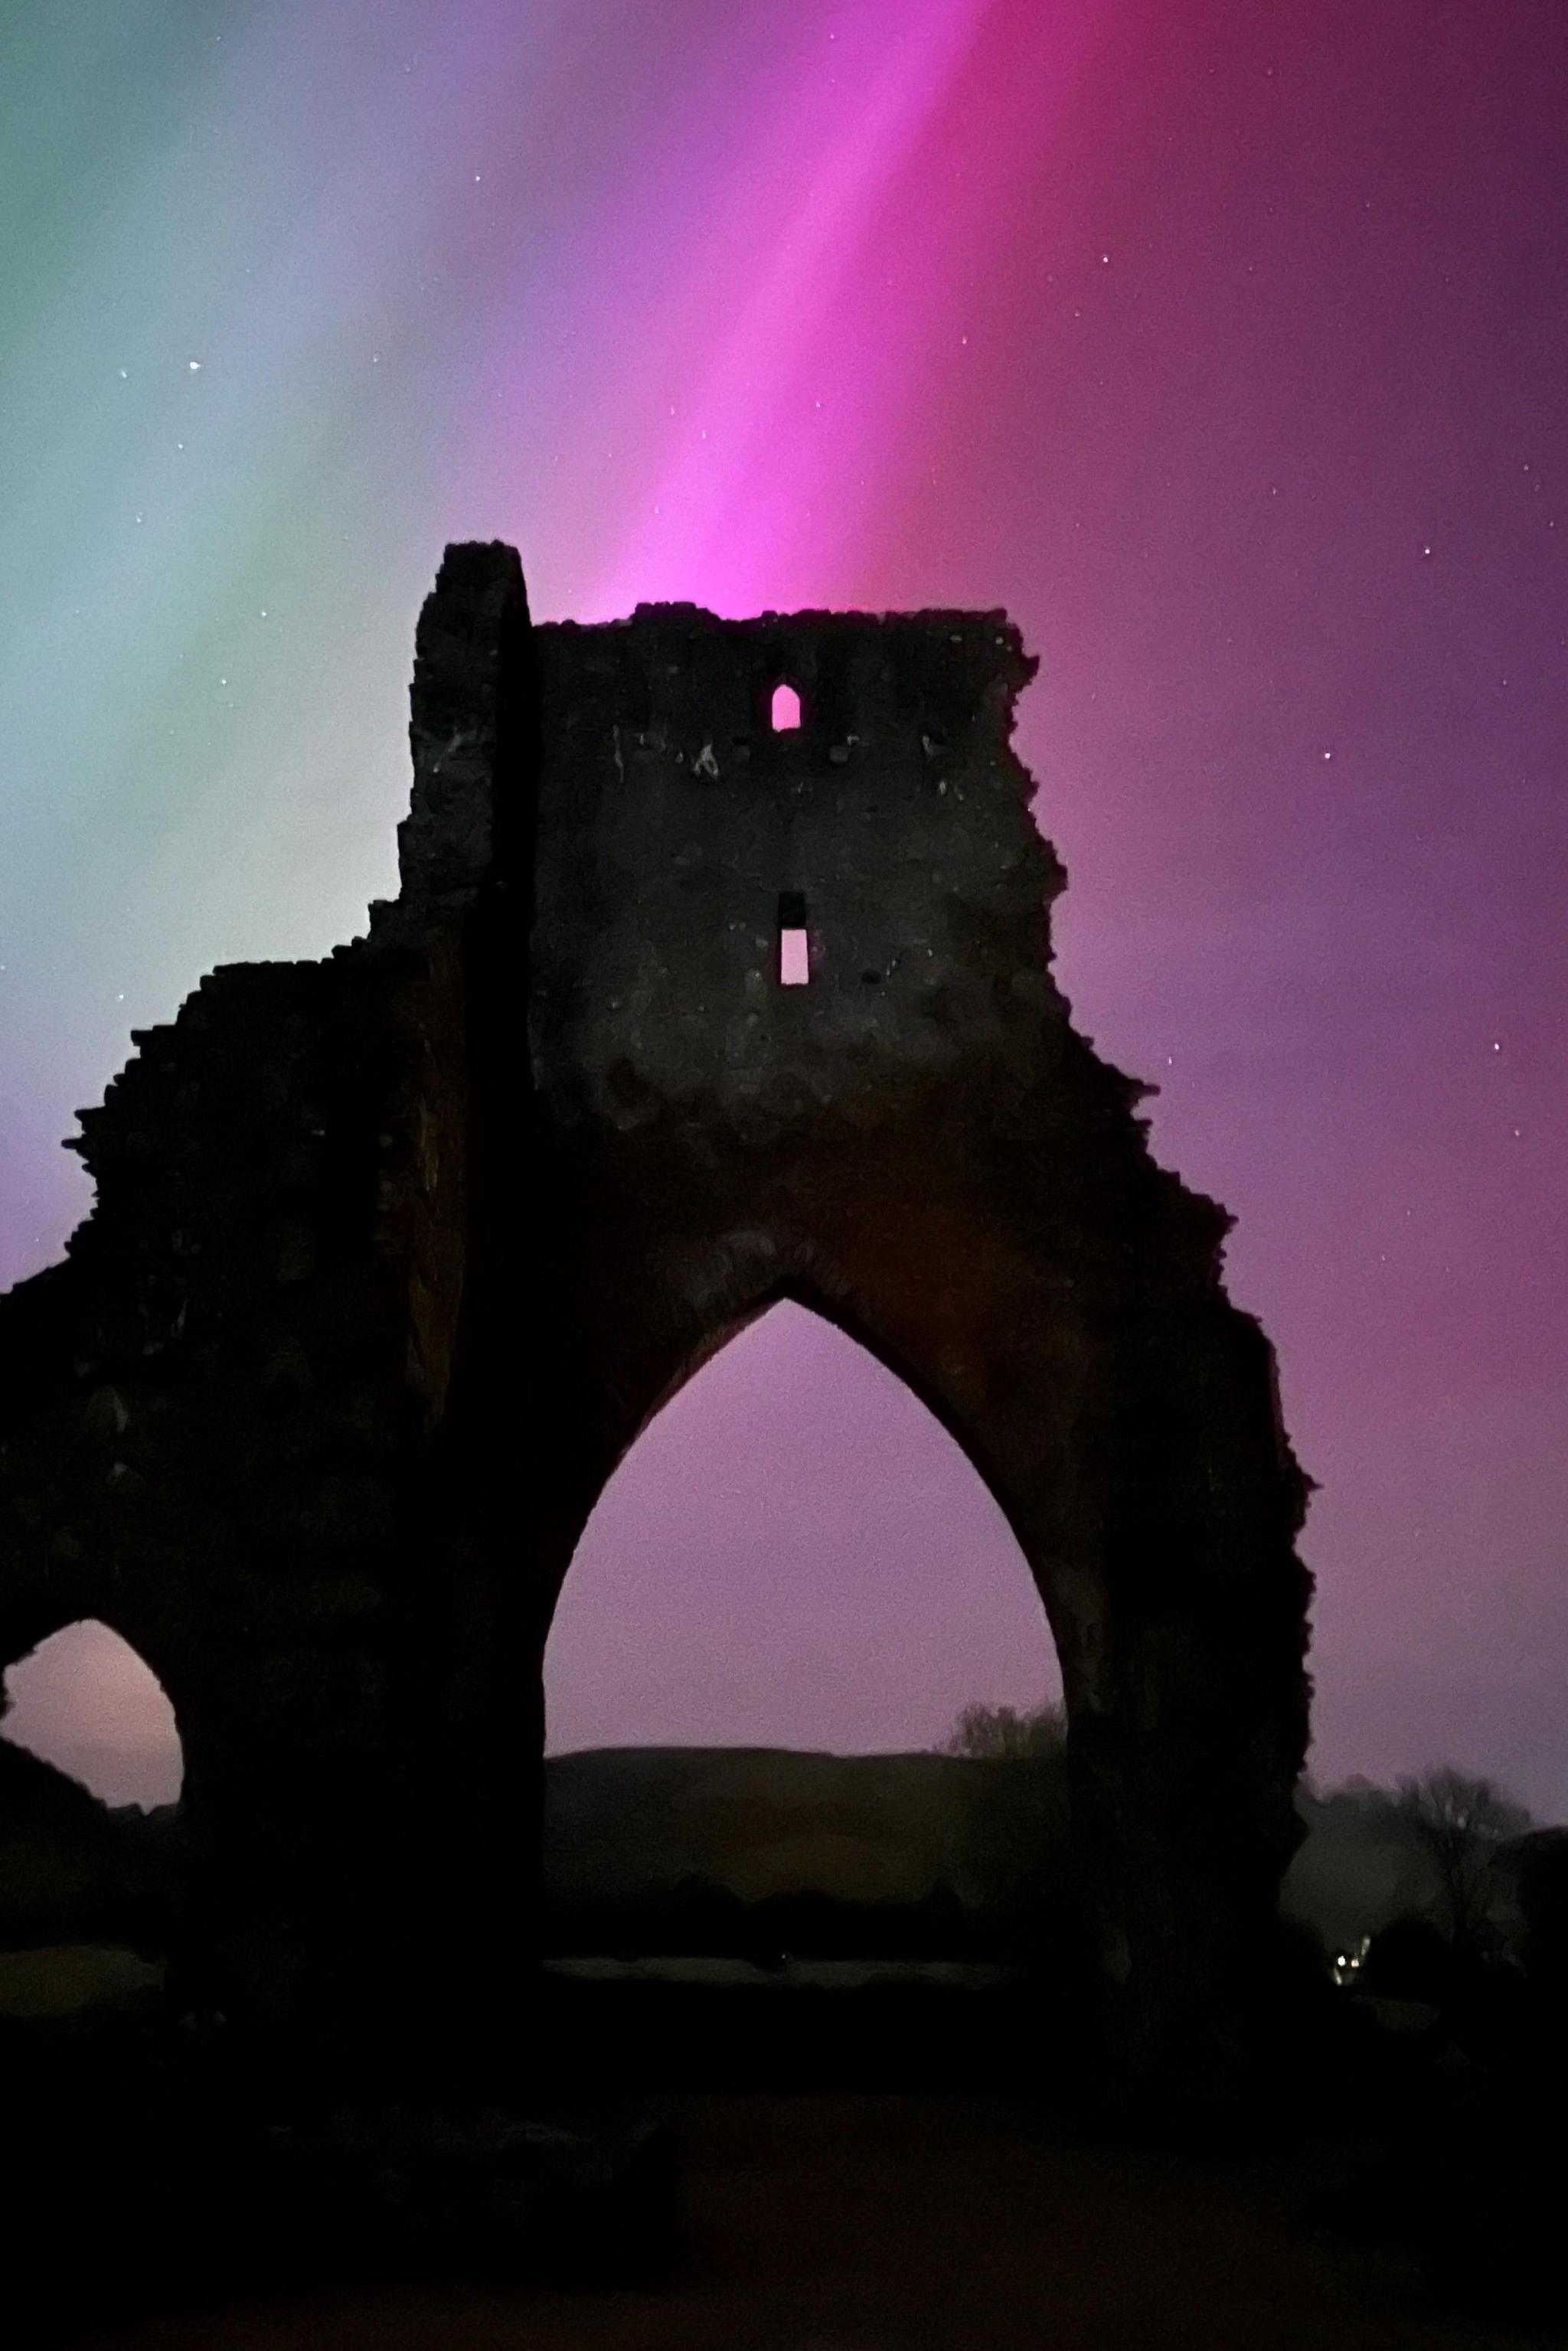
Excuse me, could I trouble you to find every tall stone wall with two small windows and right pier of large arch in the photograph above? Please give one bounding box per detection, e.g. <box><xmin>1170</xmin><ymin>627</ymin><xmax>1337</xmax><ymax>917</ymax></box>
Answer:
<box><xmin>529</xmin><ymin>592</ymin><xmax>1307</xmax><ymax>2115</ymax></box>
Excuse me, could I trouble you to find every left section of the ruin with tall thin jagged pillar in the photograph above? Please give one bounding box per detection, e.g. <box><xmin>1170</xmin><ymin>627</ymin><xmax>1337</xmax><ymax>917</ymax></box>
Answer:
<box><xmin>0</xmin><ymin>557</ymin><xmax>527</xmax><ymax>2036</ymax></box>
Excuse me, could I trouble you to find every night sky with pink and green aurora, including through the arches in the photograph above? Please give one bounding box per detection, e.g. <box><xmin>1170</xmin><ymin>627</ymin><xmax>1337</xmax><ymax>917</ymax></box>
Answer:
<box><xmin>0</xmin><ymin>0</ymin><xmax>1568</xmax><ymax>1817</ymax></box>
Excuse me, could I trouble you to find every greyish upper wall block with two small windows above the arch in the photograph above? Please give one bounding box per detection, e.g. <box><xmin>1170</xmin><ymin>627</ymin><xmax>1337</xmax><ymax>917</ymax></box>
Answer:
<box><xmin>534</xmin><ymin>604</ymin><xmax>1065</xmax><ymax>1126</ymax></box>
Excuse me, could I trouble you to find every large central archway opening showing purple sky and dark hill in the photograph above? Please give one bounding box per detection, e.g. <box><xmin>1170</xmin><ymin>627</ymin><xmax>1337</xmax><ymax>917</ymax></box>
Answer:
<box><xmin>545</xmin><ymin>1302</ymin><xmax>1065</xmax><ymax>2040</ymax></box>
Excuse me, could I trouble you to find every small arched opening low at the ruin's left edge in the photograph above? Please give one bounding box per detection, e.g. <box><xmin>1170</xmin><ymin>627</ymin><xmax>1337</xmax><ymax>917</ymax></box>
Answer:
<box><xmin>0</xmin><ymin>1618</ymin><xmax>186</xmax><ymax>1813</ymax></box>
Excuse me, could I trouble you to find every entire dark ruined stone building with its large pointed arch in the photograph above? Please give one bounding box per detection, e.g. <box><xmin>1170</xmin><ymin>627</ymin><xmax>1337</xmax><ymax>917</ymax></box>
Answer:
<box><xmin>0</xmin><ymin>545</ymin><xmax>1309</xmax><ymax>2099</ymax></box>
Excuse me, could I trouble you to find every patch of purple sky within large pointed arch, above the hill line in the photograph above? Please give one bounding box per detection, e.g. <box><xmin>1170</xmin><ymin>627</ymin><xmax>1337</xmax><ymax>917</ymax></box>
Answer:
<box><xmin>545</xmin><ymin>1295</ymin><xmax>1060</xmax><ymax>1752</ymax></box>
